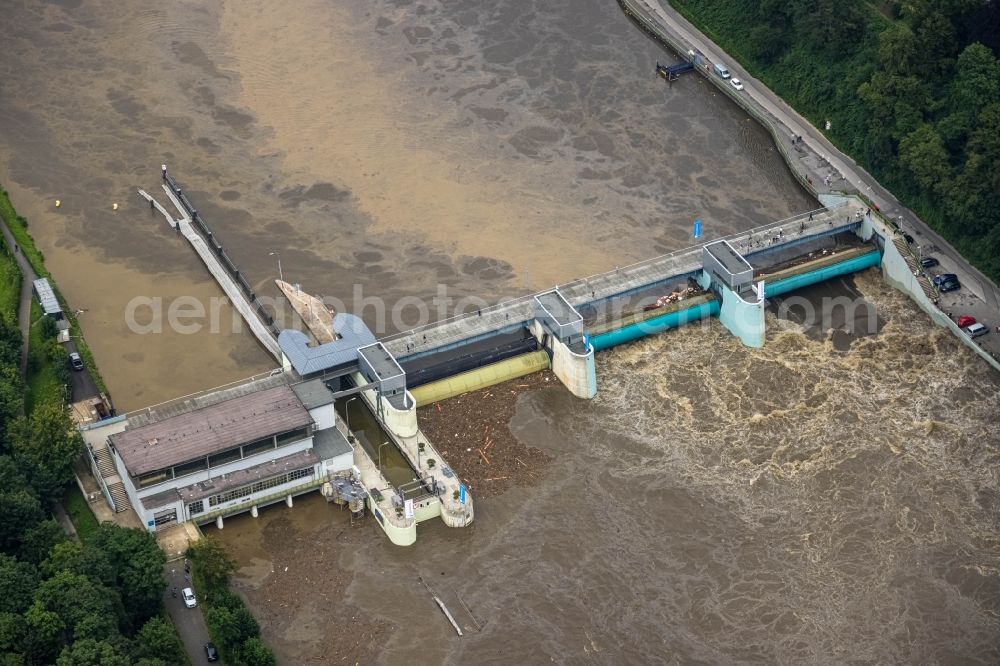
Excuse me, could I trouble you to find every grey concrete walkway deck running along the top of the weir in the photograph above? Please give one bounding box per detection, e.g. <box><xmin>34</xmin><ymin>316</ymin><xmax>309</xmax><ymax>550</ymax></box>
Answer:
<box><xmin>382</xmin><ymin>200</ymin><xmax>864</xmax><ymax>359</ymax></box>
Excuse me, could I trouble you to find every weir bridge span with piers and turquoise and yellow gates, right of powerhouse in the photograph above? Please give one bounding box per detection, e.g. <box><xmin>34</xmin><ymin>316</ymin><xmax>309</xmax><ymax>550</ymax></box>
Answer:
<box><xmin>381</xmin><ymin>198</ymin><xmax>880</xmax><ymax>402</ymax></box>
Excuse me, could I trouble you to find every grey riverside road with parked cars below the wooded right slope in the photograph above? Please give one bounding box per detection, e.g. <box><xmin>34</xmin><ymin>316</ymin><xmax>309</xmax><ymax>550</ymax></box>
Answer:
<box><xmin>618</xmin><ymin>0</ymin><xmax>1000</xmax><ymax>364</ymax></box>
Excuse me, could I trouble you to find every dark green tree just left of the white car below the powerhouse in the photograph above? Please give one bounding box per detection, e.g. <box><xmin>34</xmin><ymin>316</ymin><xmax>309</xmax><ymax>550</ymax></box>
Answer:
<box><xmin>94</xmin><ymin>523</ymin><xmax>167</xmax><ymax>626</ymax></box>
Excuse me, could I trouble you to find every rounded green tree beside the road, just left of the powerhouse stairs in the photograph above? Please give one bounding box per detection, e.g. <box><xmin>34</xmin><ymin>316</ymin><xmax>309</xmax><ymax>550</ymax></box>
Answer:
<box><xmin>8</xmin><ymin>404</ymin><xmax>83</xmax><ymax>501</ymax></box>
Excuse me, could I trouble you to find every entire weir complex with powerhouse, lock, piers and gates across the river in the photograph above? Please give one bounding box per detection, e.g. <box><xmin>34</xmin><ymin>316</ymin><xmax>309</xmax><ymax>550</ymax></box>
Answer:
<box><xmin>119</xmin><ymin>171</ymin><xmax>894</xmax><ymax>545</ymax></box>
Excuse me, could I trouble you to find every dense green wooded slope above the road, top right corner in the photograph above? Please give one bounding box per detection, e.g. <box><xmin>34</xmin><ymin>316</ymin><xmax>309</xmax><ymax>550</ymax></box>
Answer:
<box><xmin>669</xmin><ymin>0</ymin><xmax>1000</xmax><ymax>281</ymax></box>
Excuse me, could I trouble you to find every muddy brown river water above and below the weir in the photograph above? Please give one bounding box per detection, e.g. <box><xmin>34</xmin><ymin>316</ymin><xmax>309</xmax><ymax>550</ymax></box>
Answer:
<box><xmin>0</xmin><ymin>0</ymin><xmax>1000</xmax><ymax>664</ymax></box>
